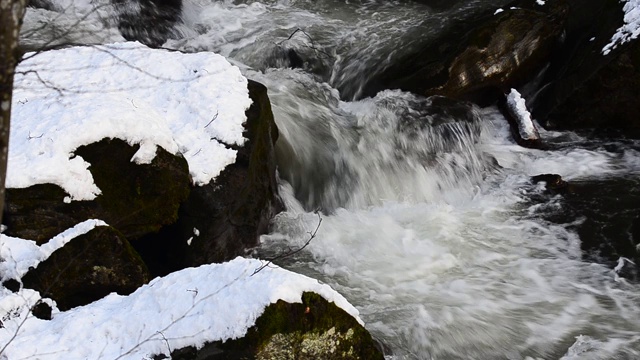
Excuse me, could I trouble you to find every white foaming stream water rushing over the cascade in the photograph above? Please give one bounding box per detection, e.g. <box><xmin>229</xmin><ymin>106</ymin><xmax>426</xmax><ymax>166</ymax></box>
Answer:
<box><xmin>22</xmin><ymin>0</ymin><xmax>640</xmax><ymax>360</ymax></box>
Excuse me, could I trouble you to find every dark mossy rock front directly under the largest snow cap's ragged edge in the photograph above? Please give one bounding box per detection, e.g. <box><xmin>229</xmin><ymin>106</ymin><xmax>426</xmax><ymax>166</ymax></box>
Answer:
<box><xmin>3</xmin><ymin>139</ymin><xmax>190</xmax><ymax>244</ymax></box>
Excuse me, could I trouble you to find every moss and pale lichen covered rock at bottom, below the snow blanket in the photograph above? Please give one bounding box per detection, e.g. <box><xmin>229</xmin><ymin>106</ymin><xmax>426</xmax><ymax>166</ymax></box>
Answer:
<box><xmin>165</xmin><ymin>292</ymin><xmax>384</xmax><ymax>360</ymax></box>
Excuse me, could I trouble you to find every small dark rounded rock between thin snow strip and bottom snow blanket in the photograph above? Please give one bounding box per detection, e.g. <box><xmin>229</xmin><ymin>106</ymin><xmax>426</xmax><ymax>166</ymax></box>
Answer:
<box><xmin>22</xmin><ymin>226</ymin><xmax>149</xmax><ymax>310</ymax></box>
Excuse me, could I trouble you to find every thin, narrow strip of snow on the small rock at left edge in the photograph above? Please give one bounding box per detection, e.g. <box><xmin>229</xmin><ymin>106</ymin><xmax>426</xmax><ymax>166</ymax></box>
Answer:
<box><xmin>0</xmin><ymin>219</ymin><xmax>107</xmax><ymax>281</ymax></box>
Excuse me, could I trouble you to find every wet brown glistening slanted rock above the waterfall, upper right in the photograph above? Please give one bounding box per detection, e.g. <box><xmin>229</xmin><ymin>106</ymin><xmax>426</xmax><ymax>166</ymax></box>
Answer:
<box><xmin>364</xmin><ymin>1</ymin><xmax>565</xmax><ymax>105</ymax></box>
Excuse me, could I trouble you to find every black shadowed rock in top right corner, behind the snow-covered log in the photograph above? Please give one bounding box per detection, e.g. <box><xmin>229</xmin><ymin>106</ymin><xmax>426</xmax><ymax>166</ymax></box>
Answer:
<box><xmin>525</xmin><ymin>0</ymin><xmax>640</xmax><ymax>138</ymax></box>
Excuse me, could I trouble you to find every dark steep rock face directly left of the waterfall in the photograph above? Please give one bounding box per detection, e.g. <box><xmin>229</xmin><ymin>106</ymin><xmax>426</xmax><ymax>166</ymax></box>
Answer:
<box><xmin>151</xmin><ymin>80</ymin><xmax>283</xmax><ymax>269</ymax></box>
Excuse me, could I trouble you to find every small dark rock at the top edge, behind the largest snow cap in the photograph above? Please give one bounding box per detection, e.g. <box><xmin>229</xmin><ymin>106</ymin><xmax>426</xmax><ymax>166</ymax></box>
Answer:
<box><xmin>112</xmin><ymin>0</ymin><xmax>182</xmax><ymax>47</ymax></box>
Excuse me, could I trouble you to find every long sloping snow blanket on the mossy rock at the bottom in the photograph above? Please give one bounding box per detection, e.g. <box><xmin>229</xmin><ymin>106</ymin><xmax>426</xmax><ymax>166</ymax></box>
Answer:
<box><xmin>0</xmin><ymin>258</ymin><xmax>362</xmax><ymax>360</ymax></box>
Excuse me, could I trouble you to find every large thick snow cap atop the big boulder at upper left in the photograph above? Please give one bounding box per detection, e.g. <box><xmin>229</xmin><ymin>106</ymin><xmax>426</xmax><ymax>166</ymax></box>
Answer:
<box><xmin>6</xmin><ymin>42</ymin><xmax>251</xmax><ymax>200</ymax></box>
